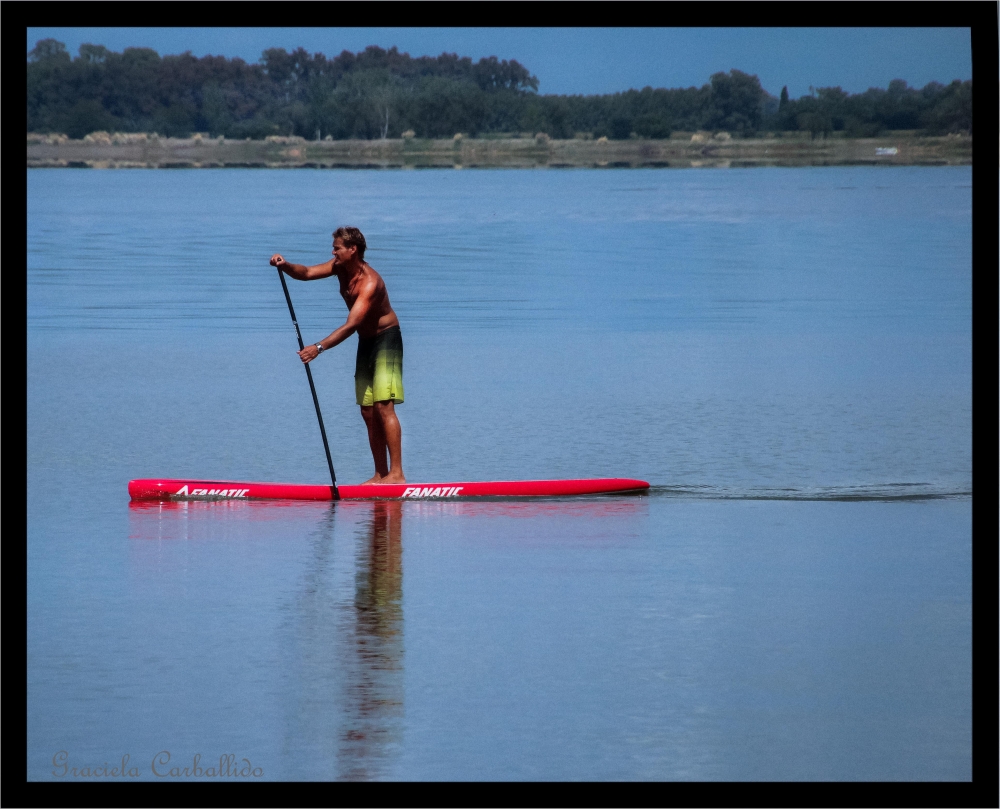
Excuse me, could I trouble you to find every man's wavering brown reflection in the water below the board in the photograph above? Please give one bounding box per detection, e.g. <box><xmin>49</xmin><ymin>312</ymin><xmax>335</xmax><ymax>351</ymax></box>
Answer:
<box><xmin>337</xmin><ymin>500</ymin><xmax>403</xmax><ymax>780</ymax></box>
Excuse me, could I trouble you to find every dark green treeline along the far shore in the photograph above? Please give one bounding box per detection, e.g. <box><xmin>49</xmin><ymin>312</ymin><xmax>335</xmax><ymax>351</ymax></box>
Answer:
<box><xmin>27</xmin><ymin>39</ymin><xmax>972</xmax><ymax>140</ymax></box>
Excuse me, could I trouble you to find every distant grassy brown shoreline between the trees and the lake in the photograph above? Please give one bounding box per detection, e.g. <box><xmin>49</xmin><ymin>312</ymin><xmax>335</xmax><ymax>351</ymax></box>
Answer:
<box><xmin>27</xmin><ymin>132</ymin><xmax>972</xmax><ymax>169</ymax></box>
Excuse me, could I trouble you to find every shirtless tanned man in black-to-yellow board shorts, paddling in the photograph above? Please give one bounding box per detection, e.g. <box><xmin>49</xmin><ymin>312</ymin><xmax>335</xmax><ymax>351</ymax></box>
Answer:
<box><xmin>271</xmin><ymin>227</ymin><xmax>406</xmax><ymax>483</ymax></box>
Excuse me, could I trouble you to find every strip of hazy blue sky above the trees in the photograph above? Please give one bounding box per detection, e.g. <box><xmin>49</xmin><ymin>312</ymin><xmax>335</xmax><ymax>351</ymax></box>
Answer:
<box><xmin>27</xmin><ymin>28</ymin><xmax>972</xmax><ymax>98</ymax></box>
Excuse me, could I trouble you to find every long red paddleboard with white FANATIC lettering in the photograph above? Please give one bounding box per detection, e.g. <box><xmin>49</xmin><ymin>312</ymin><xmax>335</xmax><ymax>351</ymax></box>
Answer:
<box><xmin>128</xmin><ymin>478</ymin><xmax>649</xmax><ymax>500</ymax></box>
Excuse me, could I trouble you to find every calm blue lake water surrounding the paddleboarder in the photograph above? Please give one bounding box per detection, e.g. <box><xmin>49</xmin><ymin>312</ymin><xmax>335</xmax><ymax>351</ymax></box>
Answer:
<box><xmin>27</xmin><ymin>167</ymin><xmax>972</xmax><ymax>781</ymax></box>
